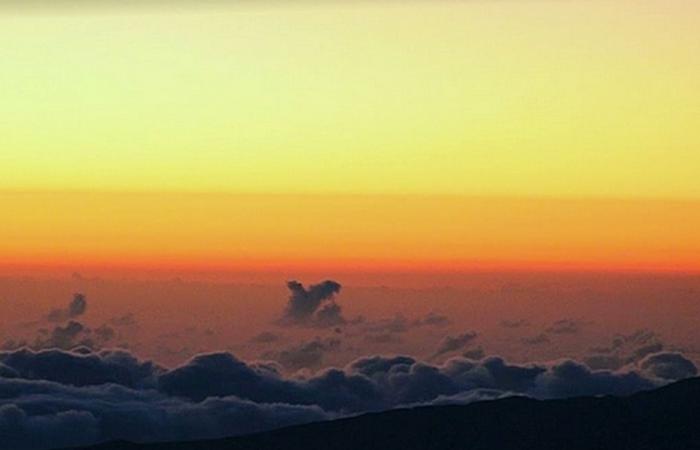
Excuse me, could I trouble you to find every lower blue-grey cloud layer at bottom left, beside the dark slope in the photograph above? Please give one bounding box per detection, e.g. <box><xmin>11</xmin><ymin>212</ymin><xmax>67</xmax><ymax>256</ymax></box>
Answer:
<box><xmin>0</xmin><ymin>379</ymin><xmax>332</xmax><ymax>450</ymax></box>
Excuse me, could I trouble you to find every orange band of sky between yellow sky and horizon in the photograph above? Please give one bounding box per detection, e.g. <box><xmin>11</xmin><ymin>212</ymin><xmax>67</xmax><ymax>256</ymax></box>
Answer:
<box><xmin>0</xmin><ymin>193</ymin><xmax>700</xmax><ymax>271</ymax></box>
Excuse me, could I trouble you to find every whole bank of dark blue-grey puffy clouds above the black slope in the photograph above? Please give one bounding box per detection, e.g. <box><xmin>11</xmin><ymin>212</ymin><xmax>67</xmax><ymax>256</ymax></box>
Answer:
<box><xmin>0</xmin><ymin>348</ymin><xmax>697</xmax><ymax>450</ymax></box>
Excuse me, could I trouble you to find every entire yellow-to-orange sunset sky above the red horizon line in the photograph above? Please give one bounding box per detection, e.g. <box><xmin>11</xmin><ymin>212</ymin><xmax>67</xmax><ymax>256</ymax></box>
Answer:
<box><xmin>0</xmin><ymin>0</ymin><xmax>700</xmax><ymax>272</ymax></box>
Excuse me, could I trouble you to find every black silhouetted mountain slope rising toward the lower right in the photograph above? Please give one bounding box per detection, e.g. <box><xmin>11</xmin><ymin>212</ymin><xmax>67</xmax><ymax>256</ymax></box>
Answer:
<box><xmin>68</xmin><ymin>378</ymin><xmax>700</xmax><ymax>450</ymax></box>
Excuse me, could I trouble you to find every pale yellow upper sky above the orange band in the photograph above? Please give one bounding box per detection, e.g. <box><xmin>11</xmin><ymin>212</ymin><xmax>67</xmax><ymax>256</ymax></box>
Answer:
<box><xmin>0</xmin><ymin>0</ymin><xmax>700</xmax><ymax>198</ymax></box>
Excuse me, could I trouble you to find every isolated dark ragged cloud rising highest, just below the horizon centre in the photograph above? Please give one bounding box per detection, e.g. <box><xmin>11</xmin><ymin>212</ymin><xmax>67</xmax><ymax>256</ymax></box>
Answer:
<box><xmin>280</xmin><ymin>280</ymin><xmax>346</xmax><ymax>327</ymax></box>
